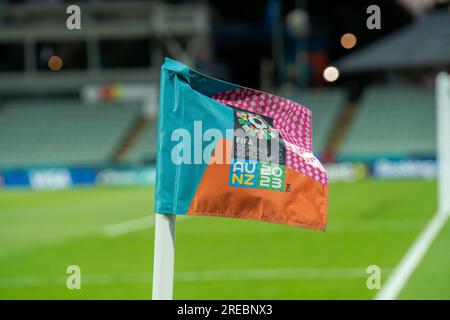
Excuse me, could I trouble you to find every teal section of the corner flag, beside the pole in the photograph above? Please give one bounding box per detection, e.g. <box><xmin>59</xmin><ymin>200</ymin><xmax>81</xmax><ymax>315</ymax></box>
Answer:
<box><xmin>155</xmin><ymin>58</ymin><xmax>239</xmax><ymax>214</ymax></box>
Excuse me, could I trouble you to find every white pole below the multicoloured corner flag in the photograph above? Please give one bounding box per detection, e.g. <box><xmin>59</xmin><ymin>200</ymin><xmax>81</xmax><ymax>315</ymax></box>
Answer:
<box><xmin>152</xmin><ymin>213</ymin><xmax>176</xmax><ymax>300</ymax></box>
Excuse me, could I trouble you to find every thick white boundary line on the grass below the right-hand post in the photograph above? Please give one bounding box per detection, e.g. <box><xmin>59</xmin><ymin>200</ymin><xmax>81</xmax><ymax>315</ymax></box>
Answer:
<box><xmin>375</xmin><ymin>212</ymin><xmax>450</xmax><ymax>300</ymax></box>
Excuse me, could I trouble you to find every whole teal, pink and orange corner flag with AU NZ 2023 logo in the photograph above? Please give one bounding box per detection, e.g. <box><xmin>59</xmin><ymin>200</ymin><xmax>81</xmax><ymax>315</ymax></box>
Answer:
<box><xmin>155</xmin><ymin>59</ymin><xmax>328</xmax><ymax>230</ymax></box>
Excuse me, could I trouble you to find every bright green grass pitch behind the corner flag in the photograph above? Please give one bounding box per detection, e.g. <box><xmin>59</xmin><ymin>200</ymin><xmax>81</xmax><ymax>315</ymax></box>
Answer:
<box><xmin>0</xmin><ymin>180</ymin><xmax>450</xmax><ymax>299</ymax></box>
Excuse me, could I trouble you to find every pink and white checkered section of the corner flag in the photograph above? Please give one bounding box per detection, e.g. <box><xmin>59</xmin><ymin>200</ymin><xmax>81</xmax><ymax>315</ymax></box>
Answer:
<box><xmin>212</xmin><ymin>88</ymin><xmax>328</xmax><ymax>184</ymax></box>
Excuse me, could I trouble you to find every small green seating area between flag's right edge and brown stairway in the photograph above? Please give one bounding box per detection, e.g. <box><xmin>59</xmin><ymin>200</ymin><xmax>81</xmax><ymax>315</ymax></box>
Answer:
<box><xmin>278</xmin><ymin>89</ymin><xmax>346</xmax><ymax>156</ymax></box>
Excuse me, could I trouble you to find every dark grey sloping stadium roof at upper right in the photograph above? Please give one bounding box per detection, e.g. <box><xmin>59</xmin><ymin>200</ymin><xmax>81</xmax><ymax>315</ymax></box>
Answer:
<box><xmin>335</xmin><ymin>11</ymin><xmax>450</xmax><ymax>73</ymax></box>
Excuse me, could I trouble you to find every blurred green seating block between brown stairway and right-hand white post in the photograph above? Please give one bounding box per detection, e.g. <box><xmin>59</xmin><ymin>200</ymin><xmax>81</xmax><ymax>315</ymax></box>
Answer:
<box><xmin>338</xmin><ymin>87</ymin><xmax>436</xmax><ymax>160</ymax></box>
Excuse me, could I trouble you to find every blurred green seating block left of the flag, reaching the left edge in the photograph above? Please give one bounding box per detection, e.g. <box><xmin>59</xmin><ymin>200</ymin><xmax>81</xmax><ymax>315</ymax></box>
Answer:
<box><xmin>0</xmin><ymin>100</ymin><xmax>140</xmax><ymax>167</ymax></box>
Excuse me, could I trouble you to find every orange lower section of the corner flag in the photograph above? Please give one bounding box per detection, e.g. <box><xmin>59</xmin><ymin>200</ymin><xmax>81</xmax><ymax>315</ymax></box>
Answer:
<box><xmin>187</xmin><ymin>139</ymin><xmax>328</xmax><ymax>231</ymax></box>
